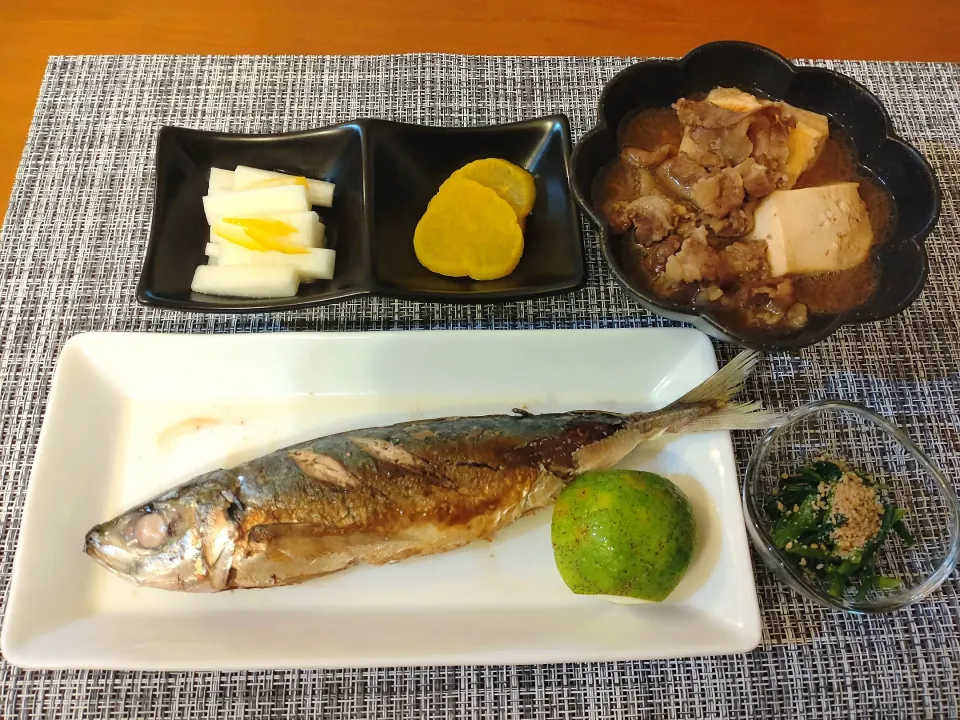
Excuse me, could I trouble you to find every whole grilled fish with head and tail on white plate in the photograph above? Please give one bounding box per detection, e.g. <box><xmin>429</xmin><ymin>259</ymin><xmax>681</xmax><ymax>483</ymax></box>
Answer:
<box><xmin>85</xmin><ymin>352</ymin><xmax>777</xmax><ymax>591</ymax></box>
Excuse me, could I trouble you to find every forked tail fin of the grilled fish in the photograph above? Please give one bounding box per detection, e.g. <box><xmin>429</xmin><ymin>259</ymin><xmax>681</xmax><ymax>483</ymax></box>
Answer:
<box><xmin>670</xmin><ymin>350</ymin><xmax>783</xmax><ymax>432</ymax></box>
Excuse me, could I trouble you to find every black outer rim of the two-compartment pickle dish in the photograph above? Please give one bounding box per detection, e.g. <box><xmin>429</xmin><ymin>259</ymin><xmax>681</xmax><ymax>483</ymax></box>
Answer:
<box><xmin>136</xmin><ymin>113</ymin><xmax>587</xmax><ymax>315</ymax></box>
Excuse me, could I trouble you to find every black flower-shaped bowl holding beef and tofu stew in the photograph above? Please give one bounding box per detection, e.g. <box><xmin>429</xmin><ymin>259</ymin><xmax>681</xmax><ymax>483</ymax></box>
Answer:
<box><xmin>571</xmin><ymin>41</ymin><xmax>940</xmax><ymax>350</ymax></box>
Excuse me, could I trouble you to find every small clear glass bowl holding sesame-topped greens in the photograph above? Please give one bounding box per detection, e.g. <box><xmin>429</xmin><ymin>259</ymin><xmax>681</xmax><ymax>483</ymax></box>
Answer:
<box><xmin>743</xmin><ymin>400</ymin><xmax>960</xmax><ymax>613</ymax></box>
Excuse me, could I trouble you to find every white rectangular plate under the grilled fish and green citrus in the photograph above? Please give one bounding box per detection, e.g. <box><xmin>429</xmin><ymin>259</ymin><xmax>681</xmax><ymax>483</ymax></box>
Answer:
<box><xmin>2</xmin><ymin>329</ymin><xmax>760</xmax><ymax>670</ymax></box>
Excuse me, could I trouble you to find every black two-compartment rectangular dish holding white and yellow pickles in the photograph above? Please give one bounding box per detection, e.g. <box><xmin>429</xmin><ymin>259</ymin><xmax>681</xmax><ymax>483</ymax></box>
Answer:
<box><xmin>137</xmin><ymin>115</ymin><xmax>586</xmax><ymax>313</ymax></box>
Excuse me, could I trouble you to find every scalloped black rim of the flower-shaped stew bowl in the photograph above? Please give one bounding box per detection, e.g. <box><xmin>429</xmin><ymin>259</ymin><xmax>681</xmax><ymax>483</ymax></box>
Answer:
<box><xmin>570</xmin><ymin>40</ymin><xmax>942</xmax><ymax>351</ymax></box>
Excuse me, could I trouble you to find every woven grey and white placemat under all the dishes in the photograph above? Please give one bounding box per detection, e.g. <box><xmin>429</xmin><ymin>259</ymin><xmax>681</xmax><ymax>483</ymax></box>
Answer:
<box><xmin>0</xmin><ymin>55</ymin><xmax>960</xmax><ymax>720</ymax></box>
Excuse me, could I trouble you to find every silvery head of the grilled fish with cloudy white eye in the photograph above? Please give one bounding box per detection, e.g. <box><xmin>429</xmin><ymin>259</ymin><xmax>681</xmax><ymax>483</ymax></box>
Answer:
<box><xmin>84</xmin><ymin>484</ymin><xmax>243</xmax><ymax>592</ymax></box>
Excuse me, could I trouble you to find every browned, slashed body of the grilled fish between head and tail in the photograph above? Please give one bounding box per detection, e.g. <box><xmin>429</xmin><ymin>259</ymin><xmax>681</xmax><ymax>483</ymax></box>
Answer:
<box><xmin>218</xmin><ymin>413</ymin><xmax>625</xmax><ymax>588</ymax></box>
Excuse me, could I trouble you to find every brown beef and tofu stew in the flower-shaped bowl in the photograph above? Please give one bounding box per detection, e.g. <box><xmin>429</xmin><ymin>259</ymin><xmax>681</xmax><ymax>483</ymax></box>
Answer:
<box><xmin>594</xmin><ymin>88</ymin><xmax>889</xmax><ymax>333</ymax></box>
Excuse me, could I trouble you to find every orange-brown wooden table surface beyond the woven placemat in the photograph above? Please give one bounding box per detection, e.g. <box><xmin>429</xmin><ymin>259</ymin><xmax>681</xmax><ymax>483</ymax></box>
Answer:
<box><xmin>0</xmin><ymin>0</ymin><xmax>960</xmax><ymax>217</ymax></box>
